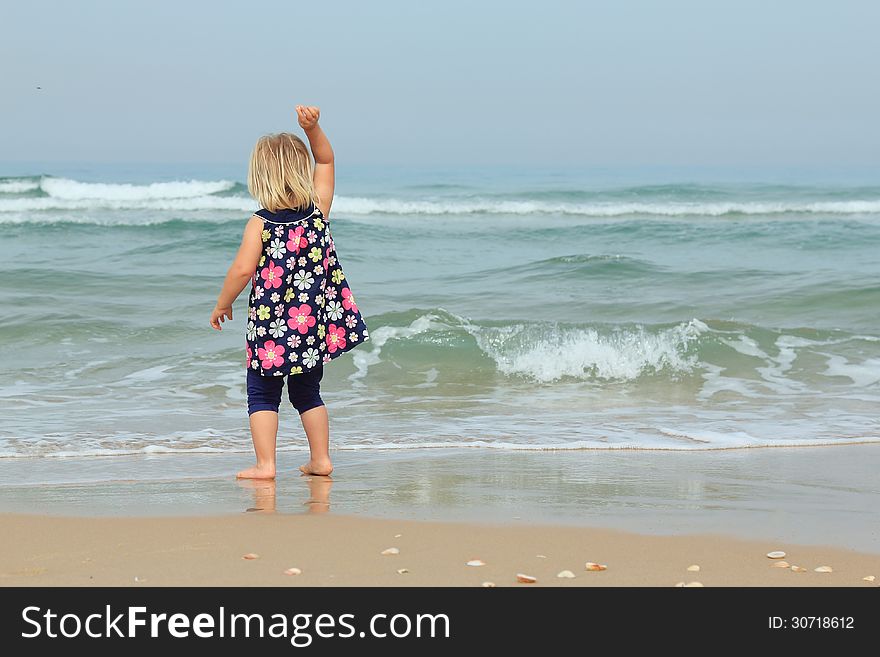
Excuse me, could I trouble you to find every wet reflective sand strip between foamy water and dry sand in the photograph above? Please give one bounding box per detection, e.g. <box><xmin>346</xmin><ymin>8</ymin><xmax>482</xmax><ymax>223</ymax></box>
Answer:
<box><xmin>0</xmin><ymin>444</ymin><xmax>880</xmax><ymax>554</ymax></box>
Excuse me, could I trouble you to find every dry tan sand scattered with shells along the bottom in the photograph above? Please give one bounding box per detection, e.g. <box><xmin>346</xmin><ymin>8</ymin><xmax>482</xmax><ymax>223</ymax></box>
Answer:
<box><xmin>0</xmin><ymin>512</ymin><xmax>880</xmax><ymax>587</ymax></box>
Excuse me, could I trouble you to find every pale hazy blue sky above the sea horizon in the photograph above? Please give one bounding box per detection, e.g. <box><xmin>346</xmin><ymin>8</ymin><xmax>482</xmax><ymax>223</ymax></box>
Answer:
<box><xmin>0</xmin><ymin>0</ymin><xmax>880</xmax><ymax>166</ymax></box>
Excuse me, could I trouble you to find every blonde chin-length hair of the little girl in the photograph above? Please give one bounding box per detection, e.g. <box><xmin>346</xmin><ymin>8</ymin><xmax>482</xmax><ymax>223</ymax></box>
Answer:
<box><xmin>248</xmin><ymin>132</ymin><xmax>320</xmax><ymax>212</ymax></box>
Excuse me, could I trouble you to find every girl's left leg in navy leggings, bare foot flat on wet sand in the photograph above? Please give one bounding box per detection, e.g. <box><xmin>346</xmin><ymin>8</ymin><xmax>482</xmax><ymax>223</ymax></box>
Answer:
<box><xmin>237</xmin><ymin>370</ymin><xmax>284</xmax><ymax>479</ymax></box>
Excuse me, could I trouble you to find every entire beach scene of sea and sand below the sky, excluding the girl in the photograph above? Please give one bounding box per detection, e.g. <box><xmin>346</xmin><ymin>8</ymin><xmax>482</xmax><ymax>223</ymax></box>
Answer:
<box><xmin>0</xmin><ymin>165</ymin><xmax>880</xmax><ymax>586</ymax></box>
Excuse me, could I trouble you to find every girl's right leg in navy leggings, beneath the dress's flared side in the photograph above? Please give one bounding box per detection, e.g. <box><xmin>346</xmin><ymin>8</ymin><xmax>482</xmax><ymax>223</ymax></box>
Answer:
<box><xmin>287</xmin><ymin>363</ymin><xmax>333</xmax><ymax>475</ymax></box>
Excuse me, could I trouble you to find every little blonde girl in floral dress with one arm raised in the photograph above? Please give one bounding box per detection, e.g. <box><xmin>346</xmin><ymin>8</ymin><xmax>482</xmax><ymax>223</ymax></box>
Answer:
<box><xmin>211</xmin><ymin>105</ymin><xmax>369</xmax><ymax>479</ymax></box>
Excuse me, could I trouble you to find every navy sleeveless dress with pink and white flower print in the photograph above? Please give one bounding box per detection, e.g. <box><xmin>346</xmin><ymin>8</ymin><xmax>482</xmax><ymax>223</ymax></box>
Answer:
<box><xmin>246</xmin><ymin>203</ymin><xmax>370</xmax><ymax>376</ymax></box>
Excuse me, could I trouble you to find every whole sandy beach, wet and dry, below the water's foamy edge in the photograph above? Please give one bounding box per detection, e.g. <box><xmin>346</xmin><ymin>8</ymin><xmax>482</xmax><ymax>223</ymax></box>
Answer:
<box><xmin>0</xmin><ymin>445</ymin><xmax>880</xmax><ymax>586</ymax></box>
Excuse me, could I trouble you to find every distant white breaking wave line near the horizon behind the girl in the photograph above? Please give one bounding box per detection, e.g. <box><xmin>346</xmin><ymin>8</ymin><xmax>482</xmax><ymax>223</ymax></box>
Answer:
<box><xmin>0</xmin><ymin>176</ymin><xmax>880</xmax><ymax>218</ymax></box>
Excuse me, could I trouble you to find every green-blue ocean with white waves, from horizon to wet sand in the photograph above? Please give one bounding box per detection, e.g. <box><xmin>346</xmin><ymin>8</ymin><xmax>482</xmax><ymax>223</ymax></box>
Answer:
<box><xmin>0</xmin><ymin>165</ymin><xmax>880</xmax><ymax>483</ymax></box>
